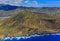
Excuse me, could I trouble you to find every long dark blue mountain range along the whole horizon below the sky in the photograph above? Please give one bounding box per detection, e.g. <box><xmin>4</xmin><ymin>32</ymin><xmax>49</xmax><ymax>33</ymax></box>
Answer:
<box><xmin>0</xmin><ymin>4</ymin><xmax>60</xmax><ymax>11</ymax></box>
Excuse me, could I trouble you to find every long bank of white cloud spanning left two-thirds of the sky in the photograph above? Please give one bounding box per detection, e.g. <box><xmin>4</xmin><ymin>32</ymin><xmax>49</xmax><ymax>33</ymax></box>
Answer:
<box><xmin>0</xmin><ymin>0</ymin><xmax>38</xmax><ymax>7</ymax></box>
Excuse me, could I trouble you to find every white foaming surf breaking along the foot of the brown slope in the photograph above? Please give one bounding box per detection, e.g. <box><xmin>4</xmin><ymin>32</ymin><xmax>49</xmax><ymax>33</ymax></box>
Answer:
<box><xmin>4</xmin><ymin>33</ymin><xmax>60</xmax><ymax>40</ymax></box>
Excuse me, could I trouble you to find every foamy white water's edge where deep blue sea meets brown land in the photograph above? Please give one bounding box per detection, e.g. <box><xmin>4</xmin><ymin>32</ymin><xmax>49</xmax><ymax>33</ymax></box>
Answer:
<box><xmin>0</xmin><ymin>33</ymin><xmax>60</xmax><ymax>41</ymax></box>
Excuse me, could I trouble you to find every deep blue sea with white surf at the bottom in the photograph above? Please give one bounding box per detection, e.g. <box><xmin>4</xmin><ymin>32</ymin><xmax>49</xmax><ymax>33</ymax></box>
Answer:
<box><xmin>3</xmin><ymin>34</ymin><xmax>60</xmax><ymax>41</ymax></box>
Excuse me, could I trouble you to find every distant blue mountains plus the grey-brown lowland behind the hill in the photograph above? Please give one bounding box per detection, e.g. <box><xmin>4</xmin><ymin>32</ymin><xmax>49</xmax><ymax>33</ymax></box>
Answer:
<box><xmin>0</xmin><ymin>4</ymin><xmax>60</xmax><ymax>17</ymax></box>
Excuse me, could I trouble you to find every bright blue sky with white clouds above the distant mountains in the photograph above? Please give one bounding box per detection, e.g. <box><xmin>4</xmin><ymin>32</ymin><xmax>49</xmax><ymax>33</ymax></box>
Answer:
<box><xmin>0</xmin><ymin>0</ymin><xmax>60</xmax><ymax>7</ymax></box>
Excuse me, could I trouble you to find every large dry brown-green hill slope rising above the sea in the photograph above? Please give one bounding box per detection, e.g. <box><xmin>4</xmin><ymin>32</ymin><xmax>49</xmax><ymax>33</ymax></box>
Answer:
<box><xmin>0</xmin><ymin>10</ymin><xmax>58</xmax><ymax>37</ymax></box>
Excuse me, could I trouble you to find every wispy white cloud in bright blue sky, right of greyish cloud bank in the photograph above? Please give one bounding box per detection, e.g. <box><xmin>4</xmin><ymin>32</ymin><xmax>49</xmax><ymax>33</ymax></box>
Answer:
<box><xmin>21</xmin><ymin>0</ymin><xmax>39</xmax><ymax>7</ymax></box>
